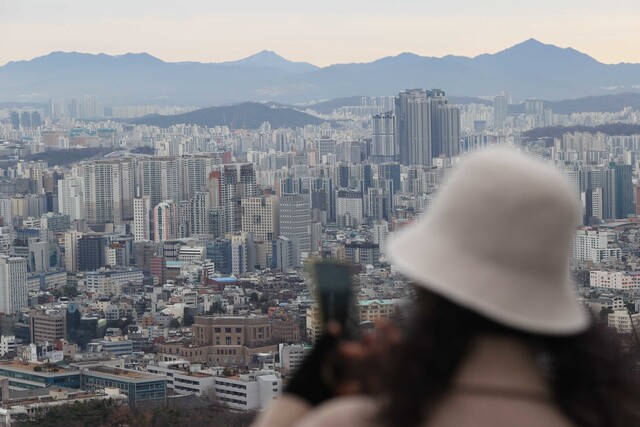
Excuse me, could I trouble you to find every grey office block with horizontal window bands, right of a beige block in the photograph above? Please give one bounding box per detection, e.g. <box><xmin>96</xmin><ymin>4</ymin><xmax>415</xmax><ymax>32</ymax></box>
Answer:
<box><xmin>280</xmin><ymin>194</ymin><xmax>311</xmax><ymax>253</ymax></box>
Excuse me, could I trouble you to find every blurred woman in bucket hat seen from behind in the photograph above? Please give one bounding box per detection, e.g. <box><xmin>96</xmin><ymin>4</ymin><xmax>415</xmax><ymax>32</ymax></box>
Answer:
<box><xmin>252</xmin><ymin>149</ymin><xmax>640</xmax><ymax>427</ymax></box>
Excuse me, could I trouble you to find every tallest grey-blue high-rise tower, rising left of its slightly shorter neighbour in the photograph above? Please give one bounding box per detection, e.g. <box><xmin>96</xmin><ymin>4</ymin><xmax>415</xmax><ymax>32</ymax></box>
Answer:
<box><xmin>395</xmin><ymin>89</ymin><xmax>432</xmax><ymax>166</ymax></box>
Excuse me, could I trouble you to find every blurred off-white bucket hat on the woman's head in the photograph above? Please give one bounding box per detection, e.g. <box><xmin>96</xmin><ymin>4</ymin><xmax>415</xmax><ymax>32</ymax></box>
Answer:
<box><xmin>387</xmin><ymin>148</ymin><xmax>590</xmax><ymax>335</ymax></box>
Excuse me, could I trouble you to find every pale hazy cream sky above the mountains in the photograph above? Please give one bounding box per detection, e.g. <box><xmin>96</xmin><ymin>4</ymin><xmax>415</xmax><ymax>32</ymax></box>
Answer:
<box><xmin>0</xmin><ymin>0</ymin><xmax>640</xmax><ymax>66</ymax></box>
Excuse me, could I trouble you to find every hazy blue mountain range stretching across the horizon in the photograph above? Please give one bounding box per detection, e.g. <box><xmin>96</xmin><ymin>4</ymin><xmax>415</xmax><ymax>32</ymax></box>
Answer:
<box><xmin>0</xmin><ymin>39</ymin><xmax>640</xmax><ymax>106</ymax></box>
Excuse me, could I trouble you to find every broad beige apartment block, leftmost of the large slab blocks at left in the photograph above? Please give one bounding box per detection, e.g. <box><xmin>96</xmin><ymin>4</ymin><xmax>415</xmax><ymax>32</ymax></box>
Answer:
<box><xmin>79</xmin><ymin>159</ymin><xmax>135</xmax><ymax>224</ymax></box>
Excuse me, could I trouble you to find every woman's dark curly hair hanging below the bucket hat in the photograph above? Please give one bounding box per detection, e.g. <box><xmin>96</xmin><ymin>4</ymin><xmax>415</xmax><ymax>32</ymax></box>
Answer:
<box><xmin>377</xmin><ymin>290</ymin><xmax>640</xmax><ymax>427</ymax></box>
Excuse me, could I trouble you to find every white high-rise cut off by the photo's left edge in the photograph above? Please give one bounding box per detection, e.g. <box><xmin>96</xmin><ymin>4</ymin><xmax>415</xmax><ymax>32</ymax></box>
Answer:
<box><xmin>0</xmin><ymin>256</ymin><xmax>29</xmax><ymax>314</ymax></box>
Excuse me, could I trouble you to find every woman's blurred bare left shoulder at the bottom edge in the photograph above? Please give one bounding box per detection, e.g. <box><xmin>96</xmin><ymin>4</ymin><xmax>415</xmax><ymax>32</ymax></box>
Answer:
<box><xmin>296</xmin><ymin>396</ymin><xmax>377</xmax><ymax>427</ymax></box>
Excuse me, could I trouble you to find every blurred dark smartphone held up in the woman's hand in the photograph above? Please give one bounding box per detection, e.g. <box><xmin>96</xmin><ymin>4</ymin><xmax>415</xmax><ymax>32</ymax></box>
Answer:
<box><xmin>311</xmin><ymin>261</ymin><xmax>358</xmax><ymax>338</ymax></box>
